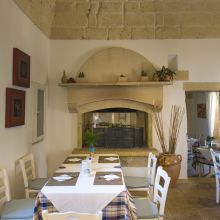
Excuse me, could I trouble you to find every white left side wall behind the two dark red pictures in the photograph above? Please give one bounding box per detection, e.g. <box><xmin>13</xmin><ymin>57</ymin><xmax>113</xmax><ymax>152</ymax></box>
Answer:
<box><xmin>0</xmin><ymin>0</ymin><xmax>49</xmax><ymax>197</ymax></box>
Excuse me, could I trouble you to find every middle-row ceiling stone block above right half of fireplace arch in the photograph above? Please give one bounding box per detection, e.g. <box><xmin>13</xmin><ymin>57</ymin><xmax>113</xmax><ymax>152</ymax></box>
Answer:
<box><xmin>124</xmin><ymin>13</ymin><xmax>155</xmax><ymax>27</ymax></box>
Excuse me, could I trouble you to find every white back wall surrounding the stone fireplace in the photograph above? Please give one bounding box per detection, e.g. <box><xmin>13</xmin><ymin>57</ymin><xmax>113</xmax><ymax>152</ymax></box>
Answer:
<box><xmin>48</xmin><ymin>40</ymin><xmax>220</xmax><ymax>178</ymax></box>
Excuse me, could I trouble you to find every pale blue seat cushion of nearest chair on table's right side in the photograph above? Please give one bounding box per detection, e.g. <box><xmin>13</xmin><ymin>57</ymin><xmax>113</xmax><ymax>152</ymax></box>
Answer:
<box><xmin>134</xmin><ymin>198</ymin><xmax>159</xmax><ymax>219</ymax></box>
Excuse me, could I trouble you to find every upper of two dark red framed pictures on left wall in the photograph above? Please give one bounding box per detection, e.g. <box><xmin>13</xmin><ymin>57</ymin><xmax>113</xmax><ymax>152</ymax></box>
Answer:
<box><xmin>13</xmin><ymin>48</ymin><xmax>30</xmax><ymax>88</ymax></box>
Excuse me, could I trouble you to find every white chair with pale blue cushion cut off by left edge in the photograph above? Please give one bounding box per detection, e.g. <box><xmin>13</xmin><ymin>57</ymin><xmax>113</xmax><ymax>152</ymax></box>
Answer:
<box><xmin>0</xmin><ymin>168</ymin><xmax>35</xmax><ymax>220</ymax></box>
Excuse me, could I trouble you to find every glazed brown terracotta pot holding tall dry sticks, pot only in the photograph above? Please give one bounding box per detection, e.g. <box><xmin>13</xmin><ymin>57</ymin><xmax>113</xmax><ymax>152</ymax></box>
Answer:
<box><xmin>158</xmin><ymin>154</ymin><xmax>182</xmax><ymax>187</ymax></box>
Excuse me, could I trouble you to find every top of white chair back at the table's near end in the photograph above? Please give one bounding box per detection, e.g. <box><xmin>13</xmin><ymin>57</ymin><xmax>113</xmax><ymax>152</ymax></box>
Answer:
<box><xmin>42</xmin><ymin>211</ymin><xmax>102</xmax><ymax>220</ymax></box>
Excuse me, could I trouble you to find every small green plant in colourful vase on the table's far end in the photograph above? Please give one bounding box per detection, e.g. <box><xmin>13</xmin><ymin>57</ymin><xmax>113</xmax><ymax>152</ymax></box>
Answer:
<box><xmin>83</xmin><ymin>129</ymin><xmax>98</xmax><ymax>157</ymax></box>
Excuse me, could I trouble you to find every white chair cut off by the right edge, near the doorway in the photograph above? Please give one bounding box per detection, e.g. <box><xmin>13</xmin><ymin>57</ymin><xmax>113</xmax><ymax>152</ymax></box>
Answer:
<box><xmin>210</xmin><ymin>148</ymin><xmax>220</xmax><ymax>203</ymax></box>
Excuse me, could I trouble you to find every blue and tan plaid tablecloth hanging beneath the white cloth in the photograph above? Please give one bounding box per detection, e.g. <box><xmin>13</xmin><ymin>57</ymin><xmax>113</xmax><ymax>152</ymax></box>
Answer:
<box><xmin>33</xmin><ymin>191</ymin><xmax>137</xmax><ymax>220</ymax></box>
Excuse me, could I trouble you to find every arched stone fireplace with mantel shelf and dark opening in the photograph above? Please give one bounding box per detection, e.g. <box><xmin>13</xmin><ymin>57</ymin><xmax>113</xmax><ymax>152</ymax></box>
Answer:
<box><xmin>60</xmin><ymin>47</ymin><xmax>171</xmax><ymax>148</ymax></box>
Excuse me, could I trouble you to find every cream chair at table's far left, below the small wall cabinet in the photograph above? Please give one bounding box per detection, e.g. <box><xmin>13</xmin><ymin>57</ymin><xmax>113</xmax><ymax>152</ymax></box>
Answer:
<box><xmin>19</xmin><ymin>154</ymin><xmax>48</xmax><ymax>198</ymax></box>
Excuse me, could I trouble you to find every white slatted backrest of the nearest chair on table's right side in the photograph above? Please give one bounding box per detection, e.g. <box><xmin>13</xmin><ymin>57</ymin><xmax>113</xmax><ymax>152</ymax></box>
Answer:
<box><xmin>153</xmin><ymin>166</ymin><xmax>170</xmax><ymax>216</ymax></box>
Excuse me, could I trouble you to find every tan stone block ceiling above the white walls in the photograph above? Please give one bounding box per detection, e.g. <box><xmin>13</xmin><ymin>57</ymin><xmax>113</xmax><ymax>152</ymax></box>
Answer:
<box><xmin>14</xmin><ymin>0</ymin><xmax>220</xmax><ymax>40</ymax></box>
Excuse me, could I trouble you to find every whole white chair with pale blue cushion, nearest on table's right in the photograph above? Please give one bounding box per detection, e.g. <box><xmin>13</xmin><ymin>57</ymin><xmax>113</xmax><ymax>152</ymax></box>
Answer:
<box><xmin>134</xmin><ymin>166</ymin><xmax>171</xmax><ymax>220</ymax></box>
